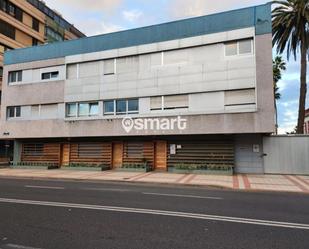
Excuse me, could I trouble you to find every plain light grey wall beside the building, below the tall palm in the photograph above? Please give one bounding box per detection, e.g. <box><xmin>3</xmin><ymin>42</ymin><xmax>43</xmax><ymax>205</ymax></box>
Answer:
<box><xmin>263</xmin><ymin>136</ymin><xmax>309</xmax><ymax>175</ymax></box>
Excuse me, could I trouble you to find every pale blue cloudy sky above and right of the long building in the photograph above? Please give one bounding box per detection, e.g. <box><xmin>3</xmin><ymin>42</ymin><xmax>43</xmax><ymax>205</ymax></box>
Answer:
<box><xmin>45</xmin><ymin>0</ymin><xmax>309</xmax><ymax>133</ymax></box>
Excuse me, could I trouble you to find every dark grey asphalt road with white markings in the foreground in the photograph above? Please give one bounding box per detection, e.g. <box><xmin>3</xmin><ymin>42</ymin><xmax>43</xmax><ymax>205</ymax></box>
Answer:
<box><xmin>0</xmin><ymin>178</ymin><xmax>309</xmax><ymax>249</ymax></box>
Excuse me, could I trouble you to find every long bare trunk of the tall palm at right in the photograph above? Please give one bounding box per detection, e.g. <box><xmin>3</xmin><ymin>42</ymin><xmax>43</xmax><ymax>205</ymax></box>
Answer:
<box><xmin>297</xmin><ymin>42</ymin><xmax>307</xmax><ymax>134</ymax></box>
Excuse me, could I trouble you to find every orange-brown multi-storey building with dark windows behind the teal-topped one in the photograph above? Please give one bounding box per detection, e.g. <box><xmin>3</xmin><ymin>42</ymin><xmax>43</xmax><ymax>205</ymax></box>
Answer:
<box><xmin>0</xmin><ymin>0</ymin><xmax>85</xmax><ymax>160</ymax></box>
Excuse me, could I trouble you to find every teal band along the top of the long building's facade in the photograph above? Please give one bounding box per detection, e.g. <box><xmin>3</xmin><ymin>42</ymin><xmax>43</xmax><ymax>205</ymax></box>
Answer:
<box><xmin>4</xmin><ymin>4</ymin><xmax>271</xmax><ymax>65</ymax></box>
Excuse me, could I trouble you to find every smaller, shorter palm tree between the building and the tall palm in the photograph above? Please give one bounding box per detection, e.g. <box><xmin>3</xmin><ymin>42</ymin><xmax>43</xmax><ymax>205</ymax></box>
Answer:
<box><xmin>273</xmin><ymin>56</ymin><xmax>286</xmax><ymax>134</ymax></box>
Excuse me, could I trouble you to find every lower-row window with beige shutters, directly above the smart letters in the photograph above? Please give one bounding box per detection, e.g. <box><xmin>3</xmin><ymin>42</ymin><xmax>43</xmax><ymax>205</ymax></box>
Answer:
<box><xmin>150</xmin><ymin>95</ymin><xmax>189</xmax><ymax>111</ymax></box>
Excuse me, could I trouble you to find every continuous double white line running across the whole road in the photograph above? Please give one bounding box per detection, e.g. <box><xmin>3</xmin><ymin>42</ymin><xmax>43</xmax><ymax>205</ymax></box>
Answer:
<box><xmin>0</xmin><ymin>198</ymin><xmax>309</xmax><ymax>230</ymax></box>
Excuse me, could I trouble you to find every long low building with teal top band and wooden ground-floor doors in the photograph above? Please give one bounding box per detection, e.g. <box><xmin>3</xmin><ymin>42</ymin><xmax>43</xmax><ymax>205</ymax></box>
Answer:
<box><xmin>1</xmin><ymin>4</ymin><xmax>275</xmax><ymax>173</ymax></box>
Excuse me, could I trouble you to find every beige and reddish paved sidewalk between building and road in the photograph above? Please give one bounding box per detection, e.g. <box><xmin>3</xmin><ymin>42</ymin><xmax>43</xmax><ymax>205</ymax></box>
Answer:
<box><xmin>0</xmin><ymin>168</ymin><xmax>309</xmax><ymax>194</ymax></box>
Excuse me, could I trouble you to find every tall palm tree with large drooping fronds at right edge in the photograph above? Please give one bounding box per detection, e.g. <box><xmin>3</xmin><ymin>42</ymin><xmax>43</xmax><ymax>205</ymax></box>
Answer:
<box><xmin>272</xmin><ymin>0</ymin><xmax>309</xmax><ymax>134</ymax></box>
